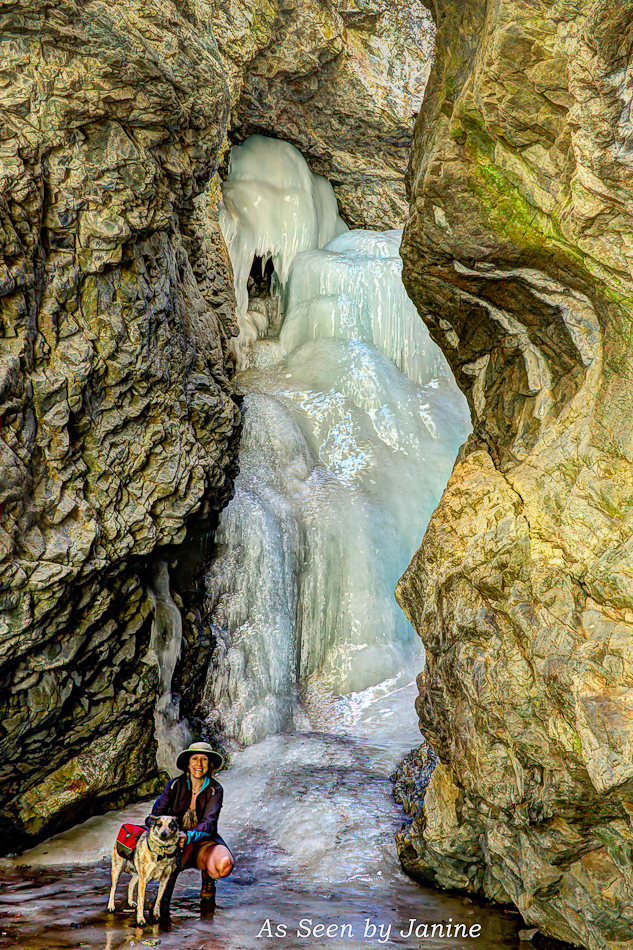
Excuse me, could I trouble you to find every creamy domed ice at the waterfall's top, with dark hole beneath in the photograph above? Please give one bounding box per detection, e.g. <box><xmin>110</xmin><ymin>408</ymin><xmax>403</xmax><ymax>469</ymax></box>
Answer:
<box><xmin>219</xmin><ymin>135</ymin><xmax>347</xmax><ymax>369</ymax></box>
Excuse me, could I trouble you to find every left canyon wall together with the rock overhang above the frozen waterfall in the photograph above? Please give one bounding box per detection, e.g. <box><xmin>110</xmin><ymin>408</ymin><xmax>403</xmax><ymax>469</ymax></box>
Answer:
<box><xmin>0</xmin><ymin>0</ymin><xmax>432</xmax><ymax>850</ymax></box>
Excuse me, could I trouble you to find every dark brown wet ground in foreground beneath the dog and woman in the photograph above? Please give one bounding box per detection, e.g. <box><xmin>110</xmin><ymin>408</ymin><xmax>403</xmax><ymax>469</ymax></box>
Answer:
<box><xmin>0</xmin><ymin>855</ymin><xmax>529</xmax><ymax>950</ymax></box>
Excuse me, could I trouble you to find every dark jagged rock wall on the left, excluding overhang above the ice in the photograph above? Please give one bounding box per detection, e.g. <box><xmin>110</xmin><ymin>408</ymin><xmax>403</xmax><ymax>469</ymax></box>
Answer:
<box><xmin>0</xmin><ymin>0</ymin><xmax>239</xmax><ymax>849</ymax></box>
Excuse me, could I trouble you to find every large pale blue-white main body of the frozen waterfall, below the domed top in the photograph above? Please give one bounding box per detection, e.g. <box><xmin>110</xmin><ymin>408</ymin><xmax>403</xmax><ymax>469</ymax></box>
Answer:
<box><xmin>204</xmin><ymin>231</ymin><xmax>469</xmax><ymax>744</ymax></box>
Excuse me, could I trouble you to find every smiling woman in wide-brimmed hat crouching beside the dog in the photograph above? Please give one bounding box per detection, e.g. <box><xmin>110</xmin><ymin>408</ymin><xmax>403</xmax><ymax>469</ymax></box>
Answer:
<box><xmin>148</xmin><ymin>742</ymin><xmax>235</xmax><ymax>901</ymax></box>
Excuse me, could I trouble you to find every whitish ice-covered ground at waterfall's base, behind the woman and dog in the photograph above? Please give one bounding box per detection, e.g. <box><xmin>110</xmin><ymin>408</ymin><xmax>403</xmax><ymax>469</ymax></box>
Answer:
<box><xmin>11</xmin><ymin>676</ymin><xmax>420</xmax><ymax>872</ymax></box>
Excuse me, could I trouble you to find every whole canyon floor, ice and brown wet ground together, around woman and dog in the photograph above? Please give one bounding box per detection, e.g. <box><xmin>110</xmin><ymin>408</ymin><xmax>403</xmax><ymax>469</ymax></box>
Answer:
<box><xmin>0</xmin><ymin>677</ymin><xmax>540</xmax><ymax>950</ymax></box>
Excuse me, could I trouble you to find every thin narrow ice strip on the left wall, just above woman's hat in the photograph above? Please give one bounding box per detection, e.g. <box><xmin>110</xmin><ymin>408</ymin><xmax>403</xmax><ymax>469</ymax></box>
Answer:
<box><xmin>145</xmin><ymin>561</ymin><xmax>192</xmax><ymax>775</ymax></box>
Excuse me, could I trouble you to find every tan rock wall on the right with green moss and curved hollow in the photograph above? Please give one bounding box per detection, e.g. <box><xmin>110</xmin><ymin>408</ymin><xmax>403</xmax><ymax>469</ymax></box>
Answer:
<box><xmin>398</xmin><ymin>0</ymin><xmax>633</xmax><ymax>948</ymax></box>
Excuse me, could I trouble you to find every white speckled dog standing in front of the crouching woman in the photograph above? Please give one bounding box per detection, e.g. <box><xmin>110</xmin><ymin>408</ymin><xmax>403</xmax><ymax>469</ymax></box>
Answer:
<box><xmin>108</xmin><ymin>815</ymin><xmax>182</xmax><ymax>927</ymax></box>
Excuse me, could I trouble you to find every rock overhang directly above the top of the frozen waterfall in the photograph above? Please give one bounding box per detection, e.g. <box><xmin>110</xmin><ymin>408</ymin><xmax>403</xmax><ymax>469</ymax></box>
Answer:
<box><xmin>214</xmin><ymin>0</ymin><xmax>434</xmax><ymax>230</ymax></box>
